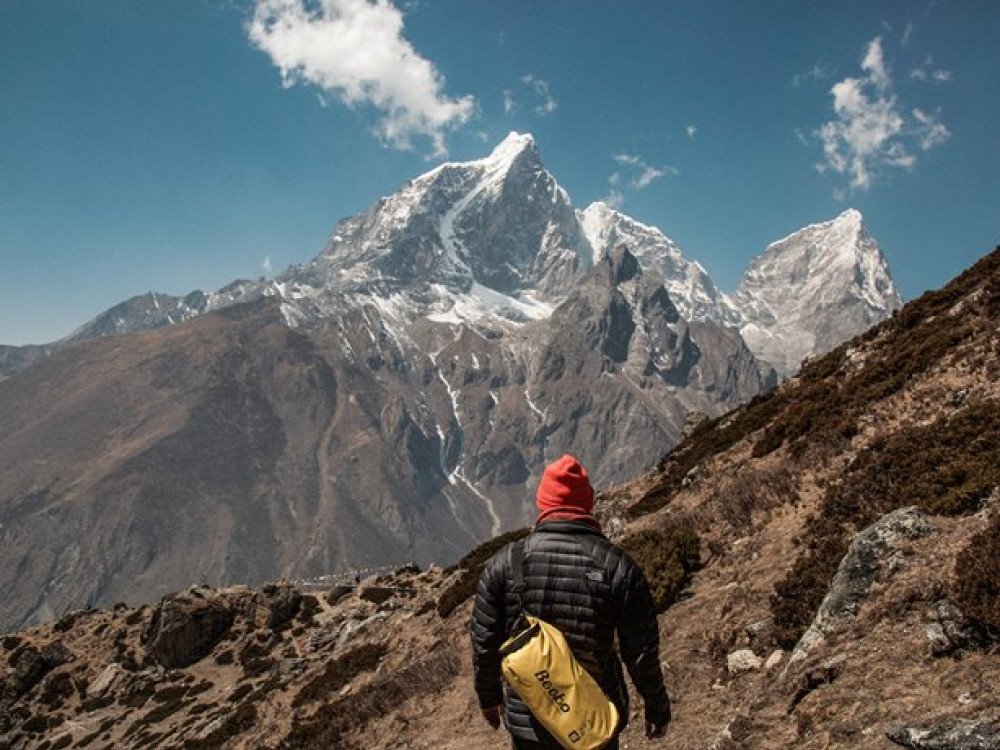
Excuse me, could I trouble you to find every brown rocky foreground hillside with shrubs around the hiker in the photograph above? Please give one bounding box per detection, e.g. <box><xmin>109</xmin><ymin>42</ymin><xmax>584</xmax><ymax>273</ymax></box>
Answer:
<box><xmin>0</xmin><ymin>250</ymin><xmax>1000</xmax><ymax>750</ymax></box>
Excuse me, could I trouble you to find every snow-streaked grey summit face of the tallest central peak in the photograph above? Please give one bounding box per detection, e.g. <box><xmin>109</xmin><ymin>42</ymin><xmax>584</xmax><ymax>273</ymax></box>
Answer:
<box><xmin>290</xmin><ymin>134</ymin><xmax>591</xmax><ymax>318</ymax></box>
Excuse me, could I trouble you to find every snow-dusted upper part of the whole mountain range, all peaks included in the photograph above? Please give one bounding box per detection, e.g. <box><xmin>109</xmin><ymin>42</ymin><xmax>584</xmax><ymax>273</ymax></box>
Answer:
<box><xmin>0</xmin><ymin>132</ymin><xmax>901</xmax><ymax>384</ymax></box>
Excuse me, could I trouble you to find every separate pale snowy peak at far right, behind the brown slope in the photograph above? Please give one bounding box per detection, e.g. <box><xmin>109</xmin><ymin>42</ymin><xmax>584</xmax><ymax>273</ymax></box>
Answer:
<box><xmin>733</xmin><ymin>210</ymin><xmax>902</xmax><ymax>376</ymax></box>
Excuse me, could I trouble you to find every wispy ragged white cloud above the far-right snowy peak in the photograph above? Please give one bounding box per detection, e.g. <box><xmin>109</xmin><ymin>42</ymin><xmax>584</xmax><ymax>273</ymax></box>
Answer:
<box><xmin>815</xmin><ymin>37</ymin><xmax>950</xmax><ymax>190</ymax></box>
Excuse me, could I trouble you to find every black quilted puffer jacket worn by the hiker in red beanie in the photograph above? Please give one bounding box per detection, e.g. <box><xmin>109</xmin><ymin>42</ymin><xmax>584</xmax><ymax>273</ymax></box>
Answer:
<box><xmin>471</xmin><ymin>521</ymin><xmax>670</xmax><ymax>747</ymax></box>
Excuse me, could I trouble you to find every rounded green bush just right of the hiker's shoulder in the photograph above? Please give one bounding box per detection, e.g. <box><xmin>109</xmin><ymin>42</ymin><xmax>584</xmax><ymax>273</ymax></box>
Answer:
<box><xmin>621</xmin><ymin>525</ymin><xmax>701</xmax><ymax>612</ymax></box>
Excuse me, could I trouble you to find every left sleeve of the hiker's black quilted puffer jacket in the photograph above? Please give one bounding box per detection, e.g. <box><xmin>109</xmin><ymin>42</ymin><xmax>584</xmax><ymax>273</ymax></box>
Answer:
<box><xmin>470</xmin><ymin>547</ymin><xmax>507</xmax><ymax>708</ymax></box>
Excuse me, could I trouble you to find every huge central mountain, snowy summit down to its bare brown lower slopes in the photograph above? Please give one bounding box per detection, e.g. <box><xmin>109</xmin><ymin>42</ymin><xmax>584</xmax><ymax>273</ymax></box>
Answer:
<box><xmin>0</xmin><ymin>135</ymin><xmax>900</xmax><ymax>627</ymax></box>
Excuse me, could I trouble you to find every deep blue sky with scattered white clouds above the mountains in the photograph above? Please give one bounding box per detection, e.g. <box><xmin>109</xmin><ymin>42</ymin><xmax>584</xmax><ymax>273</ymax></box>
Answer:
<box><xmin>0</xmin><ymin>0</ymin><xmax>1000</xmax><ymax>344</ymax></box>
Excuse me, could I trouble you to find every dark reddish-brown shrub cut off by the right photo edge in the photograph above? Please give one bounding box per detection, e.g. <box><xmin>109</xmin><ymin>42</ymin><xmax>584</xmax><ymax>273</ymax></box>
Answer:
<box><xmin>952</xmin><ymin>511</ymin><xmax>1000</xmax><ymax>639</ymax></box>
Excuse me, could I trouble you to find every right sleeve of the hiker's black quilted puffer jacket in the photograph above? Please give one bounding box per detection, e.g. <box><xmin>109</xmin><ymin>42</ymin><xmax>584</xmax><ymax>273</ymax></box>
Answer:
<box><xmin>616</xmin><ymin>554</ymin><xmax>670</xmax><ymax>724</ymax></box>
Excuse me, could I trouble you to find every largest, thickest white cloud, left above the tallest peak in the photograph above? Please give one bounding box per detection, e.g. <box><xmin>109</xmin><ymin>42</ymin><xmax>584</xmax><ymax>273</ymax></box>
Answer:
<box><xmin>247</xmin><ymin>0</ymin><xmax>475</xmax><ymax>156</ymax></box>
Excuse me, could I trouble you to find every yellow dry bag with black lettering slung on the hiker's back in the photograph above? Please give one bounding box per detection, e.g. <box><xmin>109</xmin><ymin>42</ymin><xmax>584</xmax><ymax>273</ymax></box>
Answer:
<box><xmin>500</xmin><ymin>544</ymin><xmax>618</xmax><ymax>750</ymax></box>
